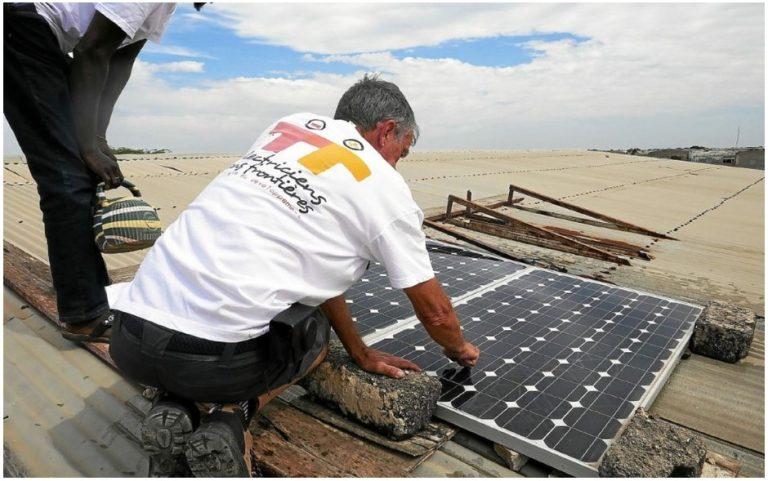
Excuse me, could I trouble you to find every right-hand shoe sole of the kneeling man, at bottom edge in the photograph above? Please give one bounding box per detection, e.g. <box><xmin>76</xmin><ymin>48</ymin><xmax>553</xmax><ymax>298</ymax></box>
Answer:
<box><xmin>185</xmin><ymin>422</ymin><xmax>251</xmax><ymax>478</ymax></box>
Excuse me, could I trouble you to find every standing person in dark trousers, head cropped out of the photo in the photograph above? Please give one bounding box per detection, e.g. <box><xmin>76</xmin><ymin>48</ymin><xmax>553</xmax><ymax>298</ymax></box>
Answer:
<box><xmin>3</xmin><ymin>3</ymin><xmax>176</xmax><ymax>342</ymax></box>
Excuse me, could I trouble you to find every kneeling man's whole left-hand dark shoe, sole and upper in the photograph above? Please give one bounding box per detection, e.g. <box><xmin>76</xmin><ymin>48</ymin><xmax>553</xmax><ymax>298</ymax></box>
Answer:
<box><xmin>141</xmin><ymin>400</ymin><xmax>195</xmax><ymax>477</ymax></box>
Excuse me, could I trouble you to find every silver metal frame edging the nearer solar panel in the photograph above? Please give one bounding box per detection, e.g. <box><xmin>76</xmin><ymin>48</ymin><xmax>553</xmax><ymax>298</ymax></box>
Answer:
<box><xmin>366</xmin><ymin>267</ymin><xmax>702</xmax><ymax>476</ymax></box>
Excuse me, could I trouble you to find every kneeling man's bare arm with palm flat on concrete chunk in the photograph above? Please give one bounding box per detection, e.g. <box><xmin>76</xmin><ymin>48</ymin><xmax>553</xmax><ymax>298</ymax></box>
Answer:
<box><xmin>322</xmin><ymin>294</ymin><xmax>421</xmax><ymax>378</ymax></box>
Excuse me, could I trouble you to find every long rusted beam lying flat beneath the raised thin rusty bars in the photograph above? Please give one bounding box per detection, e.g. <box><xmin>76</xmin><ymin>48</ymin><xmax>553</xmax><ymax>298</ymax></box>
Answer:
<box><xmin>451</xmin><ymin>220</ymin><xmax>631</xmax><ymax>265</ymax></box>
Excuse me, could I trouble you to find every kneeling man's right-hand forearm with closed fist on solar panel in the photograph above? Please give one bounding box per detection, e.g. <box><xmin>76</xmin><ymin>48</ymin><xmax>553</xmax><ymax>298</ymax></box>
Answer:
<box><xmin>405</xmin><ymin>277</ymin><xmax>480</xmax><ymax>366</ymax></box>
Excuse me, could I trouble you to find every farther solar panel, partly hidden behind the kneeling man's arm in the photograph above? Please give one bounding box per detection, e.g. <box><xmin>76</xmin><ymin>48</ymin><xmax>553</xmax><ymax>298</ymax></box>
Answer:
<box><xmin>345</xmin><ymin>241</ymin><xmax>525</xmax><ymax>336</ymax></box>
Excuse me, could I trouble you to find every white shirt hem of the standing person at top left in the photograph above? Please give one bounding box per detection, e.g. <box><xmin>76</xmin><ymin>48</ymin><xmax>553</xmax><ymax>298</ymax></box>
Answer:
<box><xmin>35</xmin><ymin>2</ymin><xmax>176</xmax><ymax>53</ymax></box>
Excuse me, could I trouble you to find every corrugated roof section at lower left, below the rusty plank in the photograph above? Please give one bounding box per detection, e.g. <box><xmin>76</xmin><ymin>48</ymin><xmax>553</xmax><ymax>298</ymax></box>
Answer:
<box><xmin>3</xmin><ymin>288</ymin><xmax>147</xmax><ymax>477</ymax></box>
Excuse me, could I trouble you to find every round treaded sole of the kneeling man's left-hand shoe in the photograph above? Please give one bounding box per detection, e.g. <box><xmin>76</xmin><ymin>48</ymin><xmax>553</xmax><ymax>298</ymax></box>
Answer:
<box><xmin>141</xmin><ymin>405</ymin><xmax>193</xmax><ymax>456</ymax></box>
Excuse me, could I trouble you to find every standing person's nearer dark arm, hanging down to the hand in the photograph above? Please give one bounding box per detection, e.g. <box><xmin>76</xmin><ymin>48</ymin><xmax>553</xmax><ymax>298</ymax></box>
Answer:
<box><xmin>69</xmin><ymin>12</ymin><xmax>126</xmax><ymax>187</ymax></box>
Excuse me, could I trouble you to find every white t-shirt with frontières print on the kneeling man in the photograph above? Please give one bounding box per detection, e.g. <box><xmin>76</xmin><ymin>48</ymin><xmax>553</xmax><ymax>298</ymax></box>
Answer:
<box><xmin>107</xmin><ymin>113</ymin><xmax>434</xmax><ymax>342</ymax></box>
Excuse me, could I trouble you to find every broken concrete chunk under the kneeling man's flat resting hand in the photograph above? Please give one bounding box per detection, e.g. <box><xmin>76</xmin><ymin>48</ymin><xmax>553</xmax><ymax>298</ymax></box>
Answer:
<box><xmin>300</xmin><ymin>341</ymin><xmax>441</xmax><ymax>440</ymax></box>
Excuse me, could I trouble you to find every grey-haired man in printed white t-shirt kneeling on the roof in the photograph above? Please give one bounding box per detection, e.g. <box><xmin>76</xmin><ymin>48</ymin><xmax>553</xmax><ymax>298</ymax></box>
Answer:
<box><xmin>110</xmin><ymin>76</ymin><xmax>479</xmax><ymax>477</ymax></box>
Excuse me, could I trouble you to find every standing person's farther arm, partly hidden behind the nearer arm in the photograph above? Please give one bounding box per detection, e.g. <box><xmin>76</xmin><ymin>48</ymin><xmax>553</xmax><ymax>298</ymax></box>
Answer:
<box><xmin>96</xmin><ymin>40</ymin><xmax>147</xmax><ymax>160</ymax></box>
